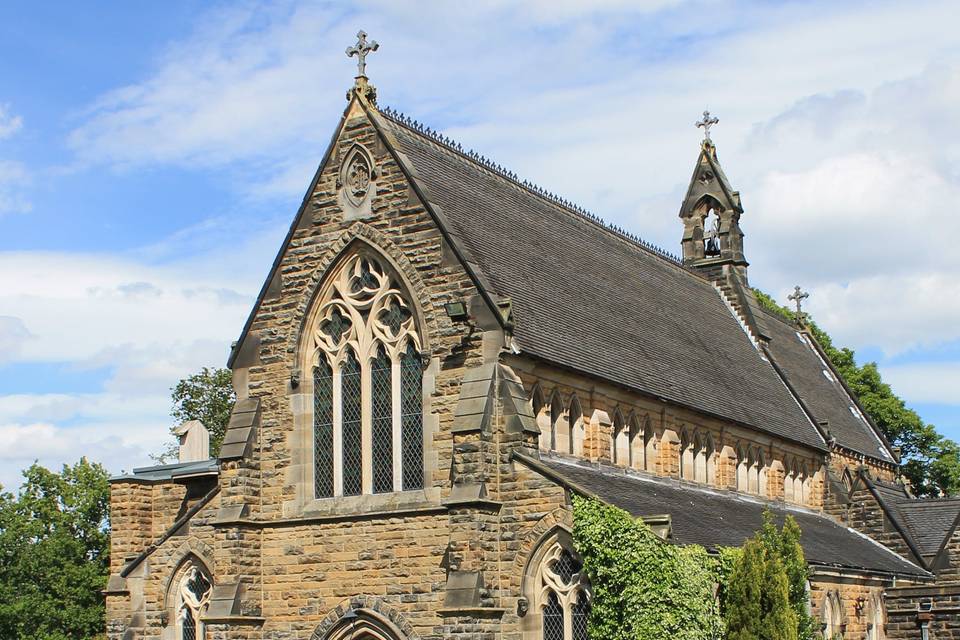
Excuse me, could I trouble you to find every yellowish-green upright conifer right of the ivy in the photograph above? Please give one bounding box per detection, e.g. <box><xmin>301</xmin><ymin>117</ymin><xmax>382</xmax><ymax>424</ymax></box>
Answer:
<box><xmin>723</xmin><ymin>511</ymin><xmax>814</xmax><ymax>640</ymax></box>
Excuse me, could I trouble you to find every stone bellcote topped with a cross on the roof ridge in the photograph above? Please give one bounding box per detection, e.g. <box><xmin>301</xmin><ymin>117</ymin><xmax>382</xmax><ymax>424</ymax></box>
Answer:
<box><xmin>680</xmin><ymin>131</ymin><xmax>748</xmax><ymax>280</ymax></box>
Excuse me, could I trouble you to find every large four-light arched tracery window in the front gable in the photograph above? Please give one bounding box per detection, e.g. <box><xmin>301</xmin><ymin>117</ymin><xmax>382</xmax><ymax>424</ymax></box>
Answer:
<box><xmin>311</xmin><ymin>253</ymin><xmax>423</xmax><ymax>498</ymax></box>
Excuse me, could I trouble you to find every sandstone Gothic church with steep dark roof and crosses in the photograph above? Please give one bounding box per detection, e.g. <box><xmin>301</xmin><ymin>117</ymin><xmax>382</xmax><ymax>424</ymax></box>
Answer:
<box><xmin>105</xmin><ymin>32</ymin><xmax>960</xmax><ymax>640</ymax></box>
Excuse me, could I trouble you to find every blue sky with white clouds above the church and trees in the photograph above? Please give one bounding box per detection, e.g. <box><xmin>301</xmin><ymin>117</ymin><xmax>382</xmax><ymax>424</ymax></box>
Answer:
<box><xmin>0</xmin><ymin>0</ymin><xmax>960</xmax><ymax>486</ymax></box>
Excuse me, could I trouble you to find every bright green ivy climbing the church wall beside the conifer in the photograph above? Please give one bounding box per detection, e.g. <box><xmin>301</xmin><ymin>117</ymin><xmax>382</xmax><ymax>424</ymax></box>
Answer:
<box><xmin>573</xmin><ymin>495</ymin><xmax>733</xmax><ymax>640</ymax></box>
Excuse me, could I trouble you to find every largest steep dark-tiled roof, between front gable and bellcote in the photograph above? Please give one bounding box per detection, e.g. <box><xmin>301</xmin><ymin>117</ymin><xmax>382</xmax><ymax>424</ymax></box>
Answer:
<box><xmin>370</xmin><ymin>110</ymin><xmax>825</xmax><ymax>449</ymax></box>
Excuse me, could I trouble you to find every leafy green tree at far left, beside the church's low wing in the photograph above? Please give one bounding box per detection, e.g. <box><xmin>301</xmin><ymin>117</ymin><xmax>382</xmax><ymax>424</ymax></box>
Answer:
<box><xmin>0</xmin><ymin>459</ymin><xmax>110</xmax><ymax>640</ymax></box>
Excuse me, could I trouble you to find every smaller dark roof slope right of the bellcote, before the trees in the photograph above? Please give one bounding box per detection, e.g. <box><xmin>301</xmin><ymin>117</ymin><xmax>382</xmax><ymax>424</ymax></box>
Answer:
<box><xmin>754</xmin><ymin>308</ymin><xmax>894</xmax><ymax>463</ymax></box>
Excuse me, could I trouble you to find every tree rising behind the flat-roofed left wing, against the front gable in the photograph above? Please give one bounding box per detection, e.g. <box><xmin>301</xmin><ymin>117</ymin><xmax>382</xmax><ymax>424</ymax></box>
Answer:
<box><xmin>154</xmin><ymin>367</ymin><xmax>237</xmax><ymax>462</ymax></box>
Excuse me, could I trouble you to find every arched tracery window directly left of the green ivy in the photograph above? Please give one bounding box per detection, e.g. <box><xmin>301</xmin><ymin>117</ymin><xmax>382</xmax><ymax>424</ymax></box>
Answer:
<box><xmin>536</xmin><ymin>539</ymin><xmax>590</xmax><ymax>640</ymax></box>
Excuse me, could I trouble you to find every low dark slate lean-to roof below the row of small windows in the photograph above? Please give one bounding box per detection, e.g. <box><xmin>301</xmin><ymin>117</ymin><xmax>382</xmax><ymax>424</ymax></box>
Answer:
<box><xmin>517</xmin><ymin>455</ymin><xmax>929</xmax><ymax>577</ymax></box>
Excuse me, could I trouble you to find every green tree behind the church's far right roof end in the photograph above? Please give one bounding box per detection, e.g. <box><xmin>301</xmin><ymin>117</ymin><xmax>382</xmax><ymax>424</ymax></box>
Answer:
<box><xmin>755</xmin><ymin>291</ymin><xmax>960</xmax><ymax>496</ymax></box>
